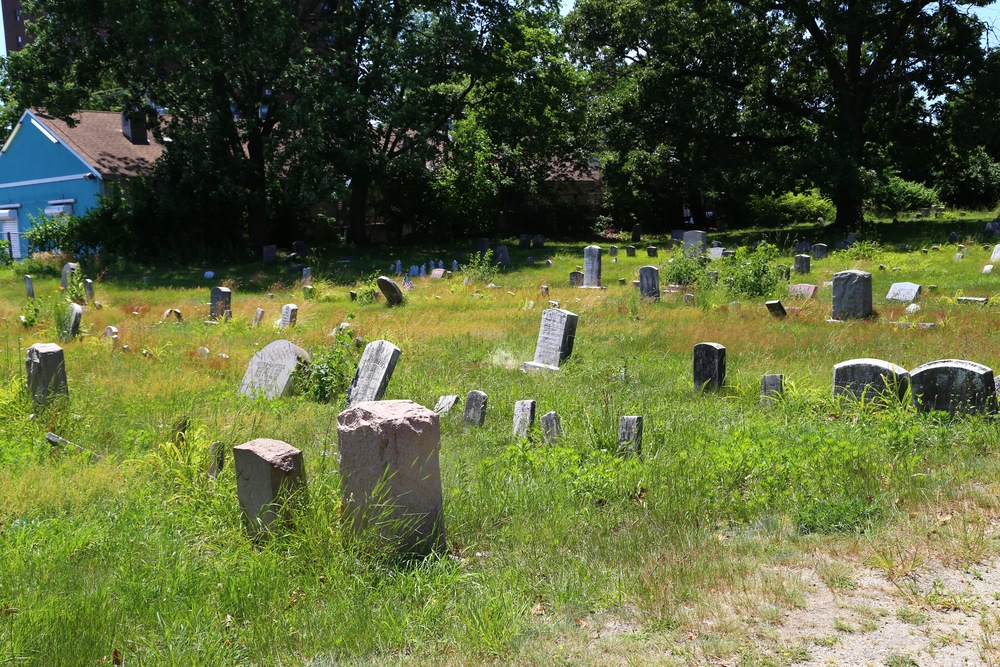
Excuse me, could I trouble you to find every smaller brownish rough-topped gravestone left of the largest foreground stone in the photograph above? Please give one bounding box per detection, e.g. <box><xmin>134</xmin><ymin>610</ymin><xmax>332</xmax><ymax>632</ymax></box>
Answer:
<box><xmin>233</xmin><ymin>438</ymin><xmax>306</xmax><ymax>535</ymax></box>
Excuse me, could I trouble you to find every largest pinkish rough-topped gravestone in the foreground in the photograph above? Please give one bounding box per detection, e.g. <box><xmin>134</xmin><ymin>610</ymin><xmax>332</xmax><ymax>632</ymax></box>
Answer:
<box><xmin>337</xmin><ymin>400</ymin><xmax>445</xmax><ymax>555</ymax></box>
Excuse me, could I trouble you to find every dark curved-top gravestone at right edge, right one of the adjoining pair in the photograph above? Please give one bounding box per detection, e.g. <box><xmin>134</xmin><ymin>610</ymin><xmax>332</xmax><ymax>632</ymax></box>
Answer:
<box><xmin>910</xmin><ymin>359</ymin><xmax>997</xmax><ymax>415</ymax></box>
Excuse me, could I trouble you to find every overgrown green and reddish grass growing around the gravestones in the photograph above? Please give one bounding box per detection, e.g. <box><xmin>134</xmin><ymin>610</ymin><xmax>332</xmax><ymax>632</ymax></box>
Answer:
<box><xmin>0</xmin><ymin>219</ymin><xmax>1000</xmax><ymax>666</ymax></box>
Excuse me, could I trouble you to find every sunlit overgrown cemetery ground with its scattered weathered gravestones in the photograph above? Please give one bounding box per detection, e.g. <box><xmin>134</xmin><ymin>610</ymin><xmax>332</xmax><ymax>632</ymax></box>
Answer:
<box><xmin>0</xmin><ymin>220</ymin><xmax>1000</xmax><ymax>665</ymax></box>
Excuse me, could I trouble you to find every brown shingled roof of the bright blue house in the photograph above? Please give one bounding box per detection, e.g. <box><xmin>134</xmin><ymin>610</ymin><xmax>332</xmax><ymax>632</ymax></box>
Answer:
<box><xmin>31</xmin><ymin>109</ymin><xmax>163</xmax><ymax>178</ymax></box>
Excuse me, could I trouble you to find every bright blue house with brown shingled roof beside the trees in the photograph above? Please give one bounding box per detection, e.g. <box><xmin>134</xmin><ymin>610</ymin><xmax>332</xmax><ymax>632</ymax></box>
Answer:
<box><xmin>0</xmin><ymin>109</ymin><xmax>163</xmax><ymax>259</ymax></box>
